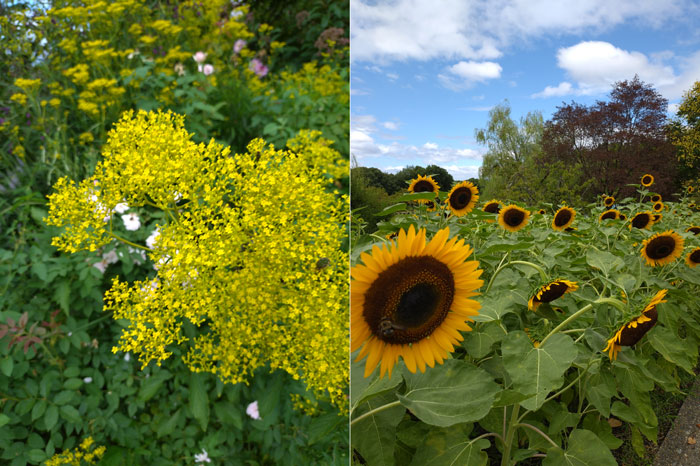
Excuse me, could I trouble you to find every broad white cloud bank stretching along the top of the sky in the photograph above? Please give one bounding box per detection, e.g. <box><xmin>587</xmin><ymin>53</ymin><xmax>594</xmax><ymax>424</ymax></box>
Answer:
<box><xmin>350</xmin><ymin>0</ymin><xmax>698</xmax><ymax>63</ymax></box>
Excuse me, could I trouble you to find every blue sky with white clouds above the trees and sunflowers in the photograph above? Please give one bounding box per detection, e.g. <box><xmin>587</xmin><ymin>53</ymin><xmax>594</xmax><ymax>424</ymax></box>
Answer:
<box><xmin>350</xmin><ymin>0</ymin><xmax>700</xmax><ymax>180</ymax></box>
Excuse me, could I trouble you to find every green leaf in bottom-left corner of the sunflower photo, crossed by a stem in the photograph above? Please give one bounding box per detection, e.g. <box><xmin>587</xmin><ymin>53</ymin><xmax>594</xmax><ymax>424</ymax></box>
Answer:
<box><xmin>350</xmin><ymin>394</ymin><xmax>406</xmax><ymax>466</ymax></box>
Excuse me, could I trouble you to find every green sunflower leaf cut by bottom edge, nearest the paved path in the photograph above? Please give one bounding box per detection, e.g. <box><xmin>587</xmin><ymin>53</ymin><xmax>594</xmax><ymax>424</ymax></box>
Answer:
<box><xmin>542</xmin><ymin>429</ymin><xmax>617</xmax><ymax>466</ymax></box>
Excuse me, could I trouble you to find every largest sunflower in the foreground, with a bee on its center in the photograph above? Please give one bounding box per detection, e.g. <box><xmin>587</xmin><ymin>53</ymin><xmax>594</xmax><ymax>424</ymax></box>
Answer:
<box><xmin>351</xmin><ymin>226</ymin><xmax>483</xmax><ymax>377</ymax></box>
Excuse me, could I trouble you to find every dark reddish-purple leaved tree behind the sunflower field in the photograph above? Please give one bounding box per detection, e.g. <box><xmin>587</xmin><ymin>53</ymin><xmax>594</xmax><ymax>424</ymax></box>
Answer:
<box><xmin>542</xmin><ymin>76</ymin><xmax>676</xmax><ymax>200</ymax></box>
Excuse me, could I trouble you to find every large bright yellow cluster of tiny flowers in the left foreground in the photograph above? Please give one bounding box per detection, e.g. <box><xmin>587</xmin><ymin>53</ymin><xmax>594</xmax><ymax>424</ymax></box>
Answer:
<box><xmin>49</xmin><ymin>111</ymin><xmax>349</xmax><ymax>410</ymax></box>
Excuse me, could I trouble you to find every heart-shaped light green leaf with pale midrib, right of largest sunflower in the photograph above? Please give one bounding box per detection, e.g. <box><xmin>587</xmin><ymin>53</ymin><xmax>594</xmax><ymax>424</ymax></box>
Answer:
<box><xmin>501</xmin><ymin>331</ymin><xmax>578</xmax><ymax>411</ymax></box>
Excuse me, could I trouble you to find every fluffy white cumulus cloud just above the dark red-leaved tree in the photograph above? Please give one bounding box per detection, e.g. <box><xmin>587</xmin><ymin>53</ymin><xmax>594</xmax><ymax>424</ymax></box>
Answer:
<box><xmin>532</xmin><ymin>41</ymin><xmax>700</xmax><ymax>99</ymax></box>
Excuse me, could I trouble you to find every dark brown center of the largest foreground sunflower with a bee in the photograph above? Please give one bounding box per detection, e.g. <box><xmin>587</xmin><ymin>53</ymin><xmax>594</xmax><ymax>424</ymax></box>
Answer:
<box><xmin>363</xmin><ymin>256</ymin><xmax>455</xmax><ymax>344</ymax></box>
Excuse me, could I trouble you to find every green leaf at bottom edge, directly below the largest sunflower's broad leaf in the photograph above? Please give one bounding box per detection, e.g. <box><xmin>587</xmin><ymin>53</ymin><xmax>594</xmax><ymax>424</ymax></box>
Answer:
<box><xmin>411</xmin><ymin>424</ymin><xmax>491</xmax><ymax>466</ymax></box>
